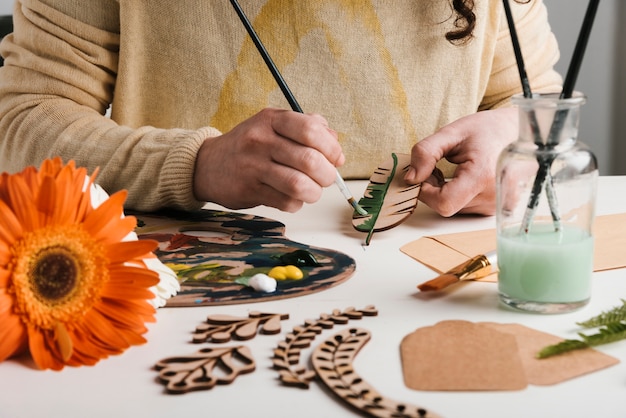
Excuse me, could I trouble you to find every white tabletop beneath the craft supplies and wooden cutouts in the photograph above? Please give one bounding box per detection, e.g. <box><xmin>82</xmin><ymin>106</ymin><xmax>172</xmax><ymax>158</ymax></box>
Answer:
<box><xmin>0</xmin><ymin>176</ymin><xmax>626</xmax><ymax>418</ymax></box>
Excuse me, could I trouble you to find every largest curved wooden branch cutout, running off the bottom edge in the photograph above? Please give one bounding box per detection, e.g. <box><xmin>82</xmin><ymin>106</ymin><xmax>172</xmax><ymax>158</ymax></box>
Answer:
<box><xmin>311</xmin><ymin>328</ymin><xmax>438</xmax><ymax>418</ymax></box>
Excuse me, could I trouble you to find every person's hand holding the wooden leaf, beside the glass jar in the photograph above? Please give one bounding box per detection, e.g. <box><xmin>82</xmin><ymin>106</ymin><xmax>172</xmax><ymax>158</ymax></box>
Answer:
<box><xmin>405</xmin><ymin>108</ymin><xmax>518</xmax><ymax>217</ymax></box>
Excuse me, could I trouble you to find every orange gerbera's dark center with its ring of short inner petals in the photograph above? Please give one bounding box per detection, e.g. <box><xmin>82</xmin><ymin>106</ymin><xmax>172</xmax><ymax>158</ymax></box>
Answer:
<box><xmin>10</xmin><ymin>225</ymin><xmax>109</xmax><ymax>330</ymax></box>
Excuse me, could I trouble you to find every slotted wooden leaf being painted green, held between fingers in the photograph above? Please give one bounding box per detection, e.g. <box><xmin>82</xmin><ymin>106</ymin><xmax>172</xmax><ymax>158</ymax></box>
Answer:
<box><xmin>352</xmin><ymin>154</ymin><xmax>420</xmax><ymax>245</ymax></box>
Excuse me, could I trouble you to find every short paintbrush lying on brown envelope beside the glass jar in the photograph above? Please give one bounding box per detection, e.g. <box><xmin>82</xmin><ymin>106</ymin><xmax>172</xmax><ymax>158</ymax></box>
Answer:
<box><xmin>417</xmin><ymin>251</ymin><xmax>496</xmax><ymax>292</ymax></box>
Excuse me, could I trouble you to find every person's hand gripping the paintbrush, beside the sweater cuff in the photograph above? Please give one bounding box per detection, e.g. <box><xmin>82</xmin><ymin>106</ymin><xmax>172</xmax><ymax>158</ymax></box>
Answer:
<box><xmin>193</xmin><ymin>109</ymin><xmax>345</xmax><ymax>212</ymax></box>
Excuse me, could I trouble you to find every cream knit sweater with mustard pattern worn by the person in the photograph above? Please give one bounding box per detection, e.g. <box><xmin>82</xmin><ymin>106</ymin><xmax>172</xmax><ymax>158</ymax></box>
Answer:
<box><xmin>0</xmin><ymin>0</ymin><xmax>561</xmax><ymax>210</ymax></box>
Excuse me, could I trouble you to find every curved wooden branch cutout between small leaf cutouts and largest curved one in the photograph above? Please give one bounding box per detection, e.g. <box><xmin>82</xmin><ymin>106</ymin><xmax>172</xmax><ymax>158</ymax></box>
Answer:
<box><xmin>272</xmin><ymin>306</ymin><xmax>378</xmax><ymax>389</ymax></box>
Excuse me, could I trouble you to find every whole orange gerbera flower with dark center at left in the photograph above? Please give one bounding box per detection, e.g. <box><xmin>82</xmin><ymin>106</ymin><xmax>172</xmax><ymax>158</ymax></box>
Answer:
<box><xmin>0</xmin><ymin>158</ymin><xmax>159</xmax><ymax>370</ymax></box>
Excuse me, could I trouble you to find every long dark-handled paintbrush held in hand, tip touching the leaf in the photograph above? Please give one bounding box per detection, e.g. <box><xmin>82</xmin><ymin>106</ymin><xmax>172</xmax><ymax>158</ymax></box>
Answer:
<box><xmin>230</xmin><ymin>0</ymin><xmax>367</xmax><ymax>216</ymax></box>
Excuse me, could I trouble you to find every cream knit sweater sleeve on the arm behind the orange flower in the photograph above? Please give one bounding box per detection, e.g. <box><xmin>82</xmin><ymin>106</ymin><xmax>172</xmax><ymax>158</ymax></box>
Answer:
<box><xmin>0</xmin><ymin>0</ymin><xmax>214</xmax><ymax>210</ymax></box>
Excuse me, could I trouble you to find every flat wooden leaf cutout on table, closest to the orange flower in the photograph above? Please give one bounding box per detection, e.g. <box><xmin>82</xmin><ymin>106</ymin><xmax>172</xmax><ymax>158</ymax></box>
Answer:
<box><xmin>155</xmin><ymin>346</ymin><xmax>256</xmax><ymax>393</ymax></box>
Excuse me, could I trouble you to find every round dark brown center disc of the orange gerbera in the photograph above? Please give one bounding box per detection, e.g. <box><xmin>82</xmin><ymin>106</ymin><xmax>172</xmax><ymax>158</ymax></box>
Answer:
<box><xmin>30</xmin><ymin>247</ymin><xmax>78</xmax><ymax>302</ymax></box>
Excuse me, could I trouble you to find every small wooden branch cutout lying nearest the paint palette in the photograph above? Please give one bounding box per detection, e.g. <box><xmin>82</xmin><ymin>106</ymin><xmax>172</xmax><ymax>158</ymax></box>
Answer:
<box><xmin>192</xmin><ymin>311</ymin><xmax>289</xmax><ymax>343</ymax></box>
